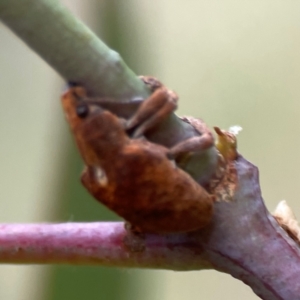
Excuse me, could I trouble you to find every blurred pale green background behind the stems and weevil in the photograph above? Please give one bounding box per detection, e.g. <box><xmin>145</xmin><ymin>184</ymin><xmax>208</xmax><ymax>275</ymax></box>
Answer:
<box><xmin>0</xmin><ymin>0</ymin><xmax>300</xmax><ymax>300</ymax></box>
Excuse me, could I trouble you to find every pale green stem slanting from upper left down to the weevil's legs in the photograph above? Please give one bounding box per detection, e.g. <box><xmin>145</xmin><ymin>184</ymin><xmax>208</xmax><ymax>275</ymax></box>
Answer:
<box><xmin>0</xmin><ymin>0</ymin><xmax>149</xmax><ymax>101</ymax></box>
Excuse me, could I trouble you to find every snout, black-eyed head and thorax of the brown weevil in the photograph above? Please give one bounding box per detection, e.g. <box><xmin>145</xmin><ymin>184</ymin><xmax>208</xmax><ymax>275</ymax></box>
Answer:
<box><xmin>62</xmin><ymin>86</ymin><xmax>129</xmax><ymax>166</ymax></box>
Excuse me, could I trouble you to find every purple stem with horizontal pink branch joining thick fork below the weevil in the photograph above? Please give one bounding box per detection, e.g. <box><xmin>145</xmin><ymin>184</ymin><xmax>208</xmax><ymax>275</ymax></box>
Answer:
<box><xmin>0</xmin><ymin>157</ymin><xmax>300</xmax><ymax>300</ymax></box>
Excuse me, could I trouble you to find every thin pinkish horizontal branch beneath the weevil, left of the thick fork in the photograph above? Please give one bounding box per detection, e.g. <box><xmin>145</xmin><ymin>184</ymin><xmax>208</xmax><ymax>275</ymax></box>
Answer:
<box><xmin>0</xmin><ymin>222</ymin><xmax>209</xmax><ymax>270</ymax></box>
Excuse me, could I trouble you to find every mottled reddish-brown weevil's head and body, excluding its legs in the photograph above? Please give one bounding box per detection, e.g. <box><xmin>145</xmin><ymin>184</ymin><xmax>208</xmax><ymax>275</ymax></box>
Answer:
<box><xmin>62</xmin><ymin>80</ymin><xmax>213</xmax><ymax>233</ymax></box>
